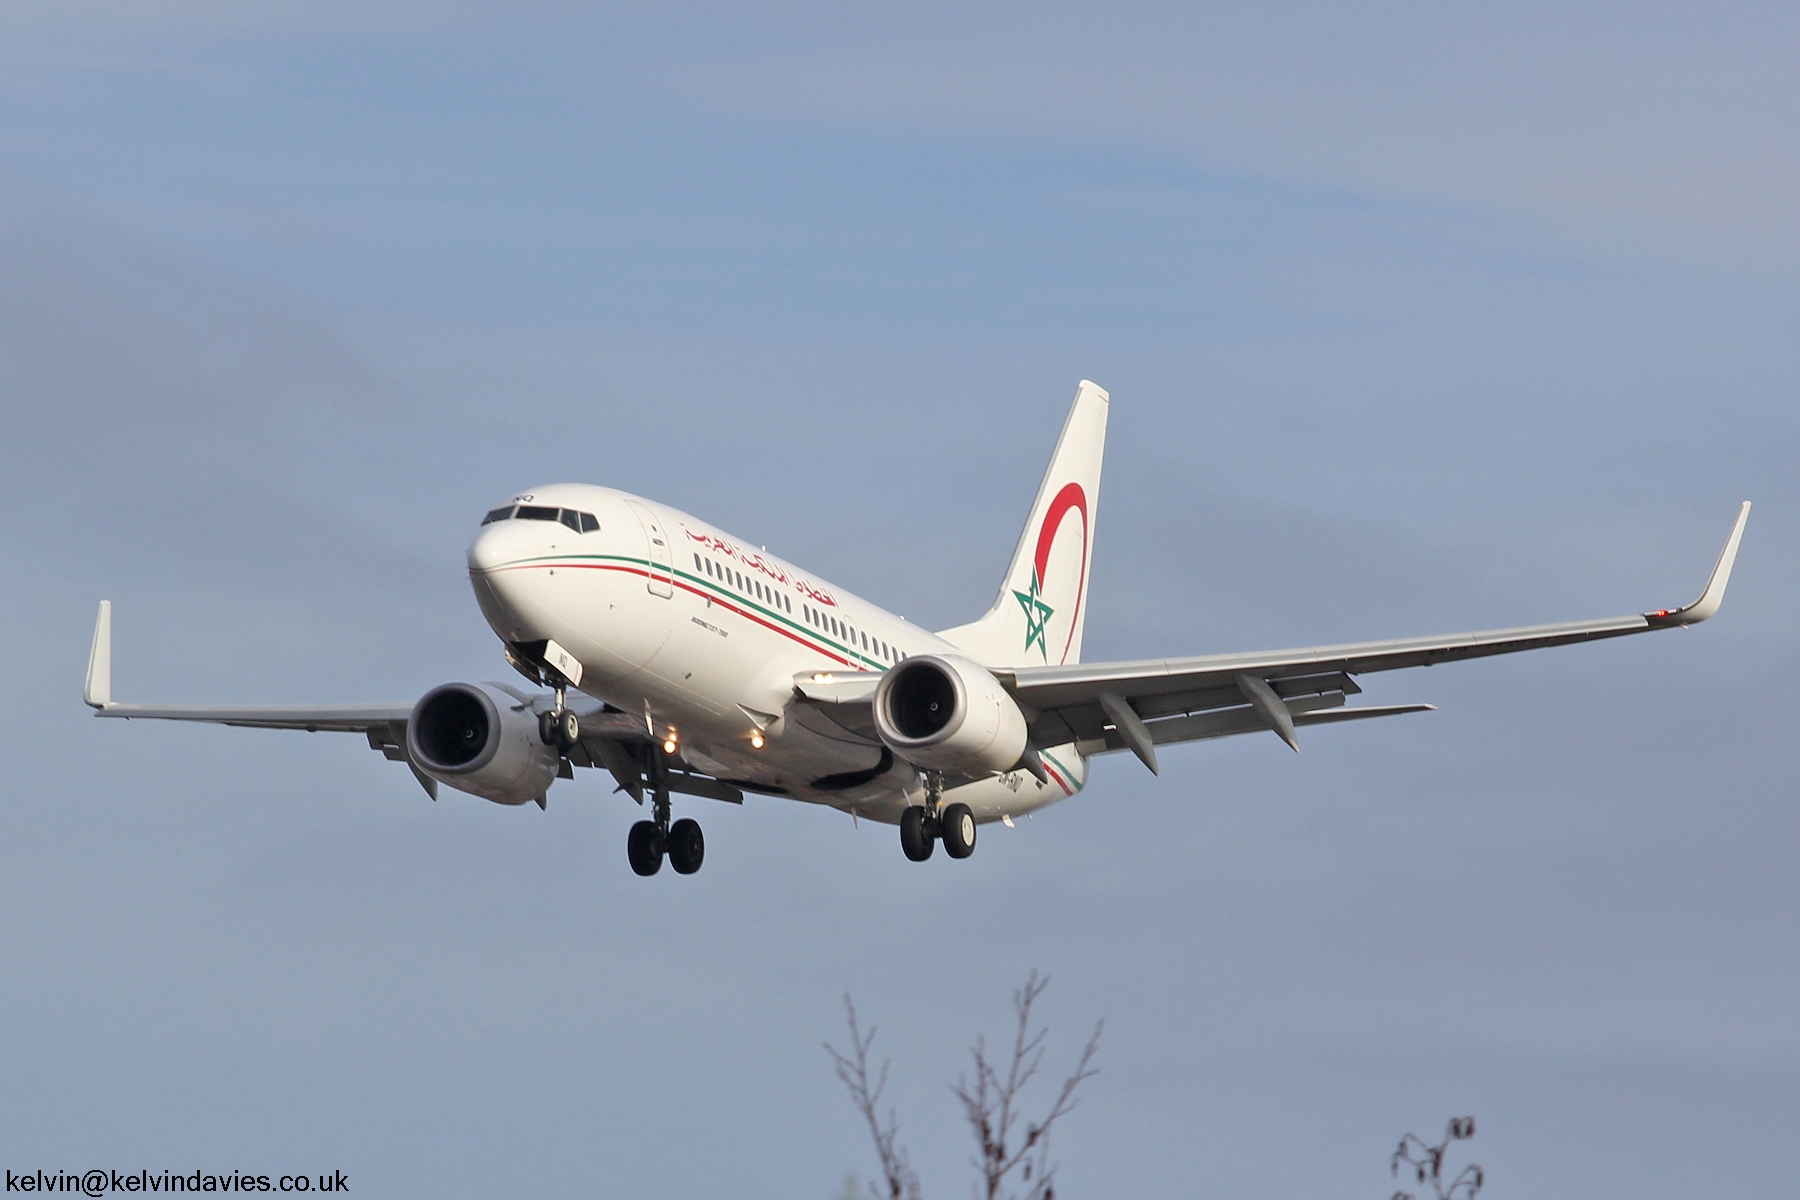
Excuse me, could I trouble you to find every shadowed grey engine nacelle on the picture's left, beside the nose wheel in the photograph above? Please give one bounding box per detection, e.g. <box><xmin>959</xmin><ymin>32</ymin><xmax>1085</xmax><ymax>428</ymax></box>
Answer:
<box><xmin>407</xmin><ymin>684</ymin><xmax>562</xmax><ymax>804</ymax></box>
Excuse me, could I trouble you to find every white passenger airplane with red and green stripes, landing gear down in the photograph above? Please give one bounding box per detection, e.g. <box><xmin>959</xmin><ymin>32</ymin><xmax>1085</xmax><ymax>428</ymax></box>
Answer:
<box><xmin>83</xmin><ymin>380</ymin><xmax>1750</xmax><ymax>876</ymax></box>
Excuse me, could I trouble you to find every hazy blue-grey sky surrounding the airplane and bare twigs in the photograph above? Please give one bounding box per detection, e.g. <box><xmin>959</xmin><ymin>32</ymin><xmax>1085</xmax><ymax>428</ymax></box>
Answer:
<box><xmin>0</xmin><ymin>4</ymin><xmax>1800</xmax><ymax>1196</ymax></box>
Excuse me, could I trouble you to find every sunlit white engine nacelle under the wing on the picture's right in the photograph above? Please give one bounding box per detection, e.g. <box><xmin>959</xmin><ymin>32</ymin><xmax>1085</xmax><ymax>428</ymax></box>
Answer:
<box><xmin>875</xmin><ymin>655</ymin><xmax>1026</xmax><ymax>777</ymax></box>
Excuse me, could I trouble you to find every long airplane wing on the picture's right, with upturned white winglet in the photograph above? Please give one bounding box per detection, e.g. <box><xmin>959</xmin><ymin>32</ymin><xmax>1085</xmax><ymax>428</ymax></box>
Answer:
<box><xmin>995</xmin><ymin>500</ymin><xmax>1750</xmax><ymax>770</ymax></box>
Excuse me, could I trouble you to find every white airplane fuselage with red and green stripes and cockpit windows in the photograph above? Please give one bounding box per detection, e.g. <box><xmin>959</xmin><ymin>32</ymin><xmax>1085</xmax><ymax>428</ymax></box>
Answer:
<box><xmin>468</xmin><ymin>484</ymin><xmax>1087</xmax><ymax>822</ymax></box>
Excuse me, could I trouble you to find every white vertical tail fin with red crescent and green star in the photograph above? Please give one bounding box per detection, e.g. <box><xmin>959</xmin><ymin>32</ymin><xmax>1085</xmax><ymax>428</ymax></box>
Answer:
<box><xmin>940</xmin><ymin>380</ymin><xmax>1112</xmax><ymax>667</ymax></box>
